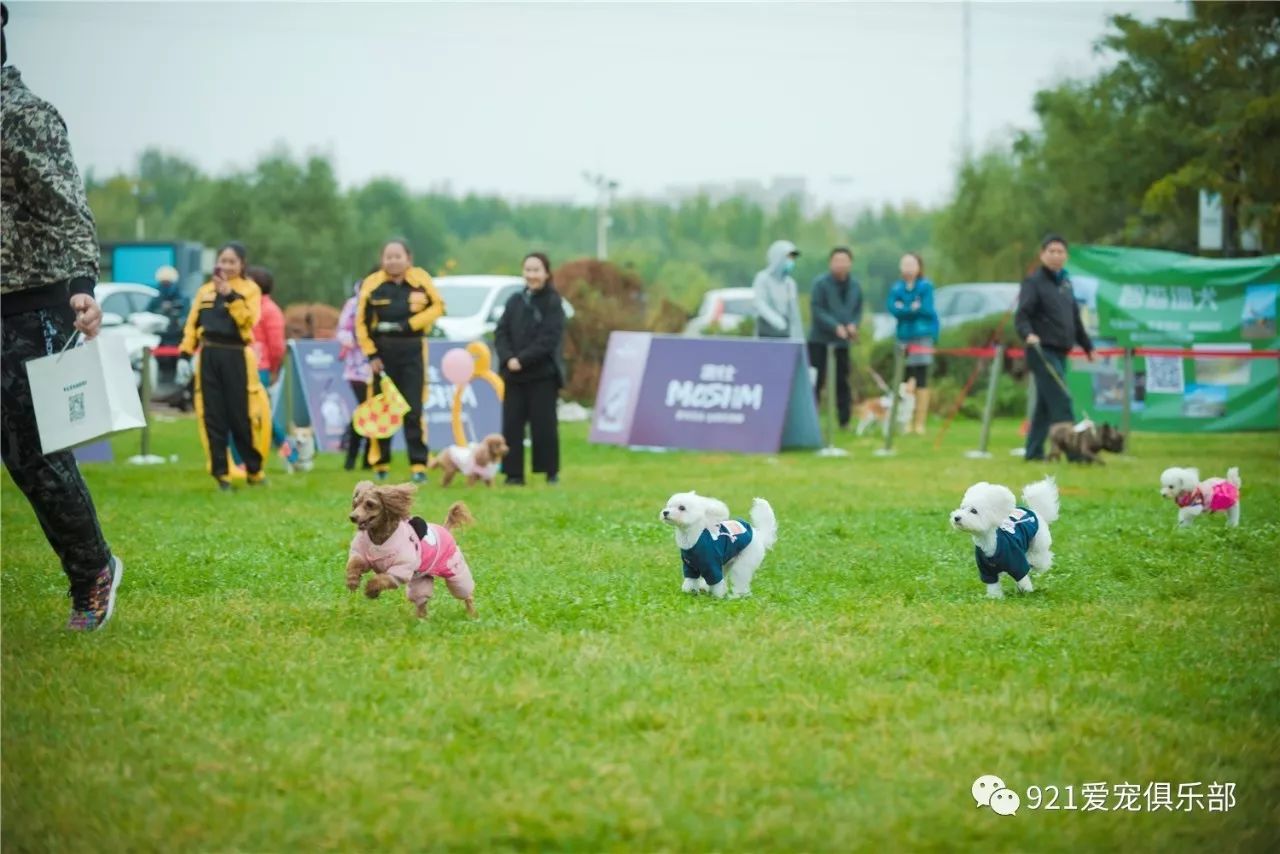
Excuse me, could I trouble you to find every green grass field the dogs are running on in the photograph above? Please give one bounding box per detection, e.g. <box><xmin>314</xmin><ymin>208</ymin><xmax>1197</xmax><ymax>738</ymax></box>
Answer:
<box><xmin>3</xmin><ymin>421</ymin><xmax>1280</xmax><ymax>851</ymax></box>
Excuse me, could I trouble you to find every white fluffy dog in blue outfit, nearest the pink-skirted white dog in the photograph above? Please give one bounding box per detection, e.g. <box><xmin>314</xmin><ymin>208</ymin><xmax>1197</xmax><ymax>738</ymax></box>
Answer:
<box><xmin>951</xmin><ymin>478</ymin><xmax>1059</xmax><ymax>599</ymax></box>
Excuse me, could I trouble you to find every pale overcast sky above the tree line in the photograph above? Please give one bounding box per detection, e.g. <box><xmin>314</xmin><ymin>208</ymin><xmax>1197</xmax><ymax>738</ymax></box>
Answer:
<box><xmin>5</xmin><ymin>0</ymin><xmax>1185</xmax><ymax>209</ymax></box>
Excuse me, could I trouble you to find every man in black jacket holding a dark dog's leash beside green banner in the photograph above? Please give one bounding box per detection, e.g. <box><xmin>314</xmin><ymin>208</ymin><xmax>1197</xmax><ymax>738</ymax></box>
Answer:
<box><xmin>1014</xmin><ymin>234</ymin><xmax>1093</xmax><ymax>460</ymax></box>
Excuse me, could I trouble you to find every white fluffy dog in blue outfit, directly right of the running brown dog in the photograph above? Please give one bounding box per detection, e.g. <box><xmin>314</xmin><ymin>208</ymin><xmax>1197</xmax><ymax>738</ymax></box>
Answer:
<box><xmin>659</xmin><ymin>492</ymin><xmax>778</xmax><ymax>599</ymax></box>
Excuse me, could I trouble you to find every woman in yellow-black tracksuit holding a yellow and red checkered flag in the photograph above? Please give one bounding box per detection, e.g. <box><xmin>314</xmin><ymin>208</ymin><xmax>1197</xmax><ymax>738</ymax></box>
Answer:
<box><xmin>356</xmin><ymin>241</ymin><xmax>444</xmax><ymax>483</ymax></box>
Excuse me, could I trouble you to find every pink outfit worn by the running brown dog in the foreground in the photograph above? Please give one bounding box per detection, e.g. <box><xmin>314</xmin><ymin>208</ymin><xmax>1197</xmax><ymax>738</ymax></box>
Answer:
<box><xmin>349</xmin><ymin>516</ymin><xmax>476</xmax><ymax>604</ymax></box>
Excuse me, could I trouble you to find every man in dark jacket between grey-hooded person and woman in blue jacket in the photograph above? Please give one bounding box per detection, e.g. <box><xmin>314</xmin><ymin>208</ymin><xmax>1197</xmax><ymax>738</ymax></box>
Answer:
<box><xmin>809</xmin><ymin>246</ymin><xmax>863</xmax><ymax>428</ymax></box>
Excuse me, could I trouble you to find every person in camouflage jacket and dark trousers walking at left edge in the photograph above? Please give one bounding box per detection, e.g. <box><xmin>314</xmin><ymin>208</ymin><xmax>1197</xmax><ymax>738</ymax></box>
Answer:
<box><xmin>0</xmin><ymin>4</ymin><xmax>124</xmax><ymax>631</ymax></box>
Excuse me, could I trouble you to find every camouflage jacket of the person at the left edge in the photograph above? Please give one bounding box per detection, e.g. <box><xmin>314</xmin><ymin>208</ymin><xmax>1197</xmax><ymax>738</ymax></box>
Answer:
<box><xmin>0</xmin><ymin>65</ymin><xmax>99</xmax><ymax>307</ymax></box>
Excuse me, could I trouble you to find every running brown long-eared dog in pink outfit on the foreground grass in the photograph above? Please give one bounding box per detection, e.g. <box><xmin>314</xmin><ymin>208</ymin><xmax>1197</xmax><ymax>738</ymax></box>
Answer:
<box><xmin>347</xmin><ymin>480</ymin><xmax>476</xmax><ymax>617</ymax></box>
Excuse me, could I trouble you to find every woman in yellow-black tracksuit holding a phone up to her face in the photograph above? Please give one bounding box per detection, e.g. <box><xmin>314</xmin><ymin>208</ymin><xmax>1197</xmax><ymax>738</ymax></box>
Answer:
<box><xmin>179</xmin><ymin>243</ymin><xmax>271</xmax><ymax>489</ymax></box>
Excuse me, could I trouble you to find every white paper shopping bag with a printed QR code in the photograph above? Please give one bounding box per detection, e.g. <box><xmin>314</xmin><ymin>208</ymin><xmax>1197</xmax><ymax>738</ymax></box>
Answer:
<box><xmin>27</xmin><ymin>335</ymin><xmax>146</xmax><ymax>453</ymax></box>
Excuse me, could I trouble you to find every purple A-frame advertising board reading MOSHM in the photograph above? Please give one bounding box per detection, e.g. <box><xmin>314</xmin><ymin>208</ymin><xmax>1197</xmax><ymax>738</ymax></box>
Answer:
<box><xmin>591</xmin><ymin>333</ymin><xmax>820</xmax><ymax>453</ymax></box>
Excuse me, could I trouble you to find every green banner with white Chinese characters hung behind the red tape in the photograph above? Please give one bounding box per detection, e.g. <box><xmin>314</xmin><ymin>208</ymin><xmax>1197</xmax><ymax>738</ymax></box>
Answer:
<box><xmin>1068</xmin><ymin>246</ymin><xmax>1280</xmax><ymax>433</ymax></box>
